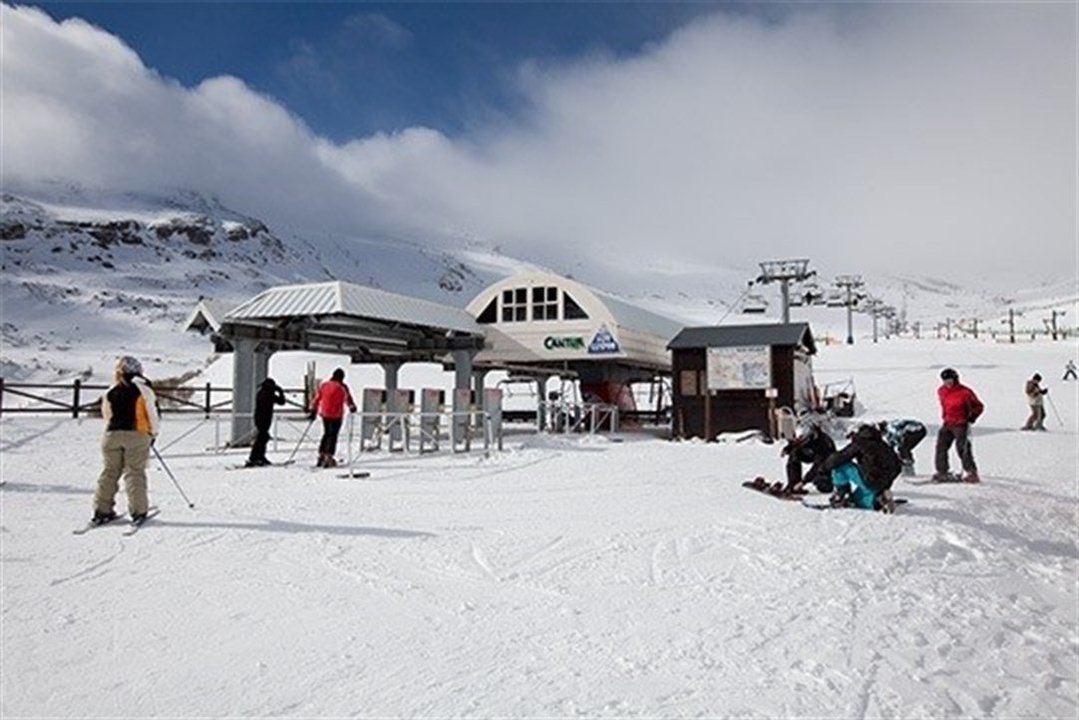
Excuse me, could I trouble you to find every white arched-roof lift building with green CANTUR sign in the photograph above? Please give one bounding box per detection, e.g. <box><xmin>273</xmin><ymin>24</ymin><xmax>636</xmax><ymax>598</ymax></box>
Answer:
<box><xmin>466</xmin><ymin>272</ymin><xmax>684</xmax><ymax>410</ymax></box>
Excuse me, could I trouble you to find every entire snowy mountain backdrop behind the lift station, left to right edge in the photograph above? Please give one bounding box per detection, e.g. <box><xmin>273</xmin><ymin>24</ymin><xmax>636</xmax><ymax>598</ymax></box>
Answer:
<box><xmin>0</xmin><ymin>184</ymin><xmax>1079</xmax><ymax>388</ymax></box>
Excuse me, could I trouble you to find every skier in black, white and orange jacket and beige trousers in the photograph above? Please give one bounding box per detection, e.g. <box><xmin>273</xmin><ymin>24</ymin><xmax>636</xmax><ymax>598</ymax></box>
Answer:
<box><xmin>91</xmin><ymin>355</ymin><xmax>160</xmax><ymax>525</ymax></box>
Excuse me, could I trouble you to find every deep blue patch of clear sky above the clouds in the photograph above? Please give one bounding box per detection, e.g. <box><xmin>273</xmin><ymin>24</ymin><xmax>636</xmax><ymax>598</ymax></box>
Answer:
<box><xmin>35</xmin><ymin>2</ymin><xmax>725</xmax><ymax>140</ymax></box>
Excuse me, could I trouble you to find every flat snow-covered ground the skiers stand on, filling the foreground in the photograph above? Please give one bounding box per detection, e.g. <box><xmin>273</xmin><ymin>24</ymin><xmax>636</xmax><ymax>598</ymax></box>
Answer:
<box><xmin>0</xmin><ymin>340</ymin><xmax>1079</xmax><ymax>718</ymax></box>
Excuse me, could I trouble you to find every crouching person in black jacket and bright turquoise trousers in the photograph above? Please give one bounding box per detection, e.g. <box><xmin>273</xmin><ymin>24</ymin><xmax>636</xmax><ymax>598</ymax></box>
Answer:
<box><xmin>823</xmin><ymin>425</ymin><xmax>902</xmax><ymax>513</ymax></box>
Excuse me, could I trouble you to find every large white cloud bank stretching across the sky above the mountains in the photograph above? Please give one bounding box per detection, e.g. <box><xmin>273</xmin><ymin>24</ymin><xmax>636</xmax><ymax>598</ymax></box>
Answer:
<box><xmin>2</xmin><ymin>3</ymin><xmax>1076</xmax><ymax>289</ymax></box>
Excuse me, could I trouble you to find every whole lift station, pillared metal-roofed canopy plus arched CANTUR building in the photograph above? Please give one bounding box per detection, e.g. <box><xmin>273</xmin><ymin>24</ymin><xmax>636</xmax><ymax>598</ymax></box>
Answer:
<box><xmin>187</xmin><ymin>273</ymin><xmax>682</xmax><ymax>441</ymax></box>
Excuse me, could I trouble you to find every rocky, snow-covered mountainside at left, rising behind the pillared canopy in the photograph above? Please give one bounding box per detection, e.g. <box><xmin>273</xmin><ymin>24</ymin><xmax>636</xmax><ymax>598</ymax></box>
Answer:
<box><xmin>0</xmin><ymin>188</ymin><xmax>535</xmax><ymax>380</ymax></box>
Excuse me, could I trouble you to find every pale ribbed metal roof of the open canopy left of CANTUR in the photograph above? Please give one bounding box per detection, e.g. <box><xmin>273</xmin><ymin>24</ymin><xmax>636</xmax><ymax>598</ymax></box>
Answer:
<box><xmin>226</xmin><ymin>281</ymin><xmax>483</xmax><ymax>336</ymax></box>
